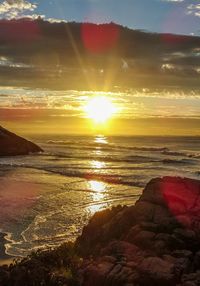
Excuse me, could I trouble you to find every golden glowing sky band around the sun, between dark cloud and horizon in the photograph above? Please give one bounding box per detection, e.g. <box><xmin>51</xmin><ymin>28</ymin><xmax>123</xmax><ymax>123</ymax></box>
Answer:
<box><xmin>0</xmin><ymin>87</ymin><xmax>200</xmax><ymax>136</ymax></box>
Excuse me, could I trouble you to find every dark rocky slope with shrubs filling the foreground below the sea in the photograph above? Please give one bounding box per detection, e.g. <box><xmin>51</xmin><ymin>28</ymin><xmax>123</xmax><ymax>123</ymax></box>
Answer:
<box><xmin>0</xmin><ymin>177</ymin><xmax>200</xmax><ymax>286</ymax></box>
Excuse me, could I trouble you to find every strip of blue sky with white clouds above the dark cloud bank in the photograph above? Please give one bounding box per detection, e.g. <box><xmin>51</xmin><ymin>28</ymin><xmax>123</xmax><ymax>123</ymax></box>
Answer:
<box><xmin>0</xmin><ymin>0</ymin><xmax>200</xmax><ymax>35</ymax></box>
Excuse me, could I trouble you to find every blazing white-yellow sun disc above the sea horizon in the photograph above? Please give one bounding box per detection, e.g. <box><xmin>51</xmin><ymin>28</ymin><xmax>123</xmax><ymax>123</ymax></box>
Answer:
<box><xmin>84</xmin><ymin>96</ymin><xmax>116</xmax><ymax>124</ymax></box>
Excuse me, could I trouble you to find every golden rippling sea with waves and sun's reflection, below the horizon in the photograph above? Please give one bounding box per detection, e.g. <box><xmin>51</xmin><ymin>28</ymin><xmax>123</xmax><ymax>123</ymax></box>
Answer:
<box><xmin>0</xmin><ymin>134</ymin><xmax>200</xmax><ymax>257</ymax></box>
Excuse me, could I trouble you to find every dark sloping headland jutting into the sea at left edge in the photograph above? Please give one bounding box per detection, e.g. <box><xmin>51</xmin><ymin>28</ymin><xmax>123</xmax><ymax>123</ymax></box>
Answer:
<box><xmin>0</xmin><ymin>126</ymin><xmax>43</xmax><ymax>156</ymax></box>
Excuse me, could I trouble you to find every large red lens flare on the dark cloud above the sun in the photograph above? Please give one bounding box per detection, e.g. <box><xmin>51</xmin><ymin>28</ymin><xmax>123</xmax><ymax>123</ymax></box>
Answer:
<box><xmin>81</xmin><ymin>23</ymin><xmax>120</xmax><ymax>54</ymax></box>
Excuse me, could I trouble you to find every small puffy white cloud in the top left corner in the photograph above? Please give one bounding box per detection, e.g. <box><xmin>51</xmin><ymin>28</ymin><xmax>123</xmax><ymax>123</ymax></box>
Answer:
<box><xmin>0</xmin><ymin>0</ymin><xmax>37</xmax><ymax>19</ymax></box>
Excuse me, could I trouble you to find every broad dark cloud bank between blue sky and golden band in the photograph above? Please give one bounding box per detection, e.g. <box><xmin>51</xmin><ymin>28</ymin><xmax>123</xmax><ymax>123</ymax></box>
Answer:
<box><xmin>0</xmin><ymin>19</ymin><xmax>200</xmax><ymax>89</ymax></box>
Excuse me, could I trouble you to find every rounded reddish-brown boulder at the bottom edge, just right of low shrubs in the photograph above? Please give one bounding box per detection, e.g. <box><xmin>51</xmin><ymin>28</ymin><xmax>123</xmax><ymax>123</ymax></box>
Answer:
<box><xmin>82</xmin><ymin>241</ymin><xmax>144</xmax><ymax>286</ymax></box>
